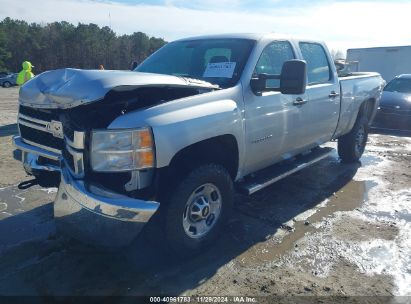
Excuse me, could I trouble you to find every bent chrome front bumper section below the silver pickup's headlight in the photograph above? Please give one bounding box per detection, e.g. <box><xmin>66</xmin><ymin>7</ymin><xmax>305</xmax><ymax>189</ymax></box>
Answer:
<box><xmin>54</xmin><ymin>168</ymin><xmax>160</xmax><ymax>247</ymax></box>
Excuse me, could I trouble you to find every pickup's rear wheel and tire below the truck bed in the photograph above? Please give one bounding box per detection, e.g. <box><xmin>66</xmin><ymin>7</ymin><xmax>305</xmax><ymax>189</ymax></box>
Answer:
<box><xmin>338</xmin><ymin>116</ymin><xmax>369</xmax><ymax>163</ymax></box>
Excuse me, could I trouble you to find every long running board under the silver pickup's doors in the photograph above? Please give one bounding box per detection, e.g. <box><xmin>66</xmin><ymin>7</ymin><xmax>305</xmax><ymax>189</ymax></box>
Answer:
<box><xmin>237</xmin><ymin>147</ymin><xmax>334</xmax><ymax>195</ymax></box>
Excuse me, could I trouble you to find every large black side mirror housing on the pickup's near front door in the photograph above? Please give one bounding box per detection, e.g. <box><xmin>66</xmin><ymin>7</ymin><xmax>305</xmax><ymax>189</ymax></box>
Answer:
<box><xmin>280</xmin><ymin>59</ymin><xmax>307</xmax><ymax>95</ymax></box>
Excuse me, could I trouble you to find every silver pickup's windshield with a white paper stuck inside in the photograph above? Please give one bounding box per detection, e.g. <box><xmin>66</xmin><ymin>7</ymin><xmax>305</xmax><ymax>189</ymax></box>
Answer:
<box><xmin>135</xmin><ymin>39</ymin><xmax>255</xmax><ymax>88</ymax></box>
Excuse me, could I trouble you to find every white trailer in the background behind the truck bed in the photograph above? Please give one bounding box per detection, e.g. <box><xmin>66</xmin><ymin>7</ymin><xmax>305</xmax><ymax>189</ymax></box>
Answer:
<box><xmin>347</xmin><ymin>45</ymin><xmax>411</xmax><ymax>82</ymax></box>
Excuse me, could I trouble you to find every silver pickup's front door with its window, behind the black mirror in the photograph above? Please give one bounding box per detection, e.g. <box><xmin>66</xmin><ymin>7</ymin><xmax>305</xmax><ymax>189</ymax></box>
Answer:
<box><xmin>244</xmin><ymin>41</ymin><xmax>306</xmax><ymax>172</ymax></box>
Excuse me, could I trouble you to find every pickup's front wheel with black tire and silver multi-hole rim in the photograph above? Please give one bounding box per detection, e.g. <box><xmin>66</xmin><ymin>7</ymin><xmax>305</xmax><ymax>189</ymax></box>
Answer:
<box><xmin>164</xmin><ymin>164</ymin><xmax>234</xmax><ymax>257</ymax></box>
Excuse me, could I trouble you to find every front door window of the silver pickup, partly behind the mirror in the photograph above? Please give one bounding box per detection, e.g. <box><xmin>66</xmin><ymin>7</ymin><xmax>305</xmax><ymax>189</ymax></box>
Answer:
<box><xmin>254</xmin><ymin>41</ymin><xmax>295</xmax><ymax>88</ymax></box>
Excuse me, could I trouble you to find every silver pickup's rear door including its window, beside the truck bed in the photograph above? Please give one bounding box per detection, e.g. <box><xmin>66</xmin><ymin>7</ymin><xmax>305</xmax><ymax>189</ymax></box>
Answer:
<box><xmin>299</xmin><ymin>42</ymin><xmax>340</xmax><ymax>145</ymax></box>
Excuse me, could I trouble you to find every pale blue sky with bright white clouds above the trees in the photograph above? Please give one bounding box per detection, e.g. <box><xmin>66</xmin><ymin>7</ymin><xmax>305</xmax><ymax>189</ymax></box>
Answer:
<box><xmin>0</xmin><ymin>0</ymin><xmax>411</xmax><ymax>53</ymax></box>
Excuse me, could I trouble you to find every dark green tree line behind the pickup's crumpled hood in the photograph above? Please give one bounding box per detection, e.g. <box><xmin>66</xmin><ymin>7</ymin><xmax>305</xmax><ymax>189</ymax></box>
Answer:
<box><xmin>0</xmin><ymin>17</ymin><xmax>166</xmax><ymax>74</ymax></box>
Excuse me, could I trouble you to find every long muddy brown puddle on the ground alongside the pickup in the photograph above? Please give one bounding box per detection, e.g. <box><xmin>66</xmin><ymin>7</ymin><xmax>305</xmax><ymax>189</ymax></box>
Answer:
<box><xmin>233</xmin><ymin>180</ymin><xmax>377</xmax><ymax>266</ymax></box>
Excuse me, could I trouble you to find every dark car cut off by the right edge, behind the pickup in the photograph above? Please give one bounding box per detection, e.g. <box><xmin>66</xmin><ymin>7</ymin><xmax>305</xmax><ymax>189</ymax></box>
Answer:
<box><xmin>372</xmin><ymin>74</ymin><xmax>411</xmax><ymax>130</ymax></box>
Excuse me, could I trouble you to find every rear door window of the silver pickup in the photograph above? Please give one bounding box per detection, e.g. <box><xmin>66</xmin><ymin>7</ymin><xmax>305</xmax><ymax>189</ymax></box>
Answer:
<box><xmin>300</xmin><ymin>42</ymin><xmax>331</xmax><ymax>85</ymax></box>
